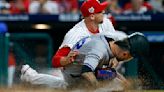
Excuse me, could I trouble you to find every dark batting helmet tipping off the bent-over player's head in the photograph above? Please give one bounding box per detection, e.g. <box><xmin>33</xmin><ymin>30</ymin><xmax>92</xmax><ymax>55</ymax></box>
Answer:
<box><xmin>128</xmin><ymin>32</ymin><xmax>149</xmax><ymax>57</ymax></box>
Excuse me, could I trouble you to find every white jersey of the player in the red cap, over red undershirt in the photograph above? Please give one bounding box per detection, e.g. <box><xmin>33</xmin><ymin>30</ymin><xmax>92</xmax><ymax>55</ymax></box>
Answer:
<box><xmin>59</xmin><ymin>17</ymin><xmax>115</xmax><ymax>49</ymax></box>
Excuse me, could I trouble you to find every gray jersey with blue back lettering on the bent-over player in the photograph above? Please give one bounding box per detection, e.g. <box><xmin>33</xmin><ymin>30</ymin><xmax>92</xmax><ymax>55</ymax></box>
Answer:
<box><xmin>65</xmin><ymin>35</ymin><xmax>113</xmax><ymax>76</ymax></box>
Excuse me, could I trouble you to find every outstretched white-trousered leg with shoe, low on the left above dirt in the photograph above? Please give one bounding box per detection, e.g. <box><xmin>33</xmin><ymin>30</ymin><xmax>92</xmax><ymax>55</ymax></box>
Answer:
<box><xmin>21</xmin><ymin>65</ymin><xmax>68</xmax><ymax>88</ymax></box>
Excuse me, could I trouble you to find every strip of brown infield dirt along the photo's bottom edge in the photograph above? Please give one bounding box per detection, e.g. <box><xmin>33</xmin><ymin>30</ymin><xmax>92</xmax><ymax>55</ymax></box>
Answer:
<box><xmin>0</xmin><ymin>85</ymin><xmax>164</xmax><ymax>92</ymax></box>
